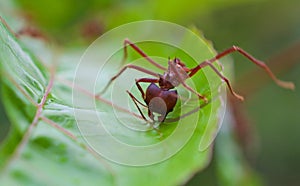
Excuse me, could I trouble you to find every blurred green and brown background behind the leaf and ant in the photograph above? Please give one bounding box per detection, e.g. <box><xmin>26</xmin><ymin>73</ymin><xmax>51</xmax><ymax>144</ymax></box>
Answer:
<box><xmin>0</xmin><ymin>0</ymin><xmax>300</xmax><ymax>185</ymax></box>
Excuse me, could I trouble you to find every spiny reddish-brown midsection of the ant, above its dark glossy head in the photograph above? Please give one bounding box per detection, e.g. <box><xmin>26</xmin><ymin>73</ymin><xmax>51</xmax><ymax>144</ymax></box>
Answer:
<box><xmin>159</xmin><ymin>58</ymin><xmax>189</xmax><ymax>90</ymax></box>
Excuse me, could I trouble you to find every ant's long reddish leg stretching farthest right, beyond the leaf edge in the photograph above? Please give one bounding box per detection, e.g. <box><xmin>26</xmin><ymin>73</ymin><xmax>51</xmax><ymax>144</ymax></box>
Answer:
<box><xmin>189</xmin><ymin>46</ymin><xmax>295</xmax><ymax>89</ymax></box>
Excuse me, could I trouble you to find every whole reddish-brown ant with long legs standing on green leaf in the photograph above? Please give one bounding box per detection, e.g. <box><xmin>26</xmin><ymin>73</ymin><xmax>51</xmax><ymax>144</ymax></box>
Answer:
<box><xmin>100</xmin><ymin>39</ymin><xmax>294</xmax><ymax>122</ymax></box>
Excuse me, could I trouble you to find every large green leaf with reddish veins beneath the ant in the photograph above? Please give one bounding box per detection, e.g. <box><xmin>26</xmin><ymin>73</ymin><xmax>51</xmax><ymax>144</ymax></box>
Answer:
<box><xmin>0</xmin><ymin>17</ymin><xmax>225</xmax><ymax>185</ymax></box>
